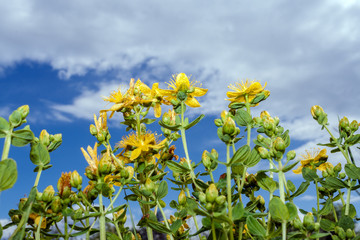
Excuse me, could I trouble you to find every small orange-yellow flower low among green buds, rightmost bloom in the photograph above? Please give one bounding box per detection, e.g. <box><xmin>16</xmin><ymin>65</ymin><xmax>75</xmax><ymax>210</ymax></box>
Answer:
<box><xmin>293</xmin><ymin>148</ymin><xmax>330</xmax><ymax>174</ymax></box>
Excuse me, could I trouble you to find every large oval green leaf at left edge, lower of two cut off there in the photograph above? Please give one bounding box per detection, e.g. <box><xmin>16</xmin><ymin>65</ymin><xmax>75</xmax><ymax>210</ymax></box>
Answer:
<box><xmin>0</xmin><ymin>158</ymin><xmax>17</xmax><ymax>192</ymax></box>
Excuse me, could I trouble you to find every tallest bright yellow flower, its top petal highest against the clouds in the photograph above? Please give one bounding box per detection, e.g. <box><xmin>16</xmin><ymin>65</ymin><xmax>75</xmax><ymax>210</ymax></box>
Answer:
<box><xmin>159</xmin><ymin>73</ymin><xmax>208</xmax><ymax>107</ymax></box>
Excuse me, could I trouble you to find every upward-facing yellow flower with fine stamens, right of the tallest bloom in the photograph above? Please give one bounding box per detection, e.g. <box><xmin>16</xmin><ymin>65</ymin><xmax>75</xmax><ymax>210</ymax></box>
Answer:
<box><xmin>226</xmin><ymin>80</ymin><xmax>270</xmax><ymax>103</ymax></box>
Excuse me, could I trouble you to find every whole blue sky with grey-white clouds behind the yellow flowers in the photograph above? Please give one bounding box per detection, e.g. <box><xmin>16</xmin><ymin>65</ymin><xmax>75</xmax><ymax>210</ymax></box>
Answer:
<box><xmin>0</xmin><ymin>0</ymin><xmax>360</xmax><ymax>227</ymax></box>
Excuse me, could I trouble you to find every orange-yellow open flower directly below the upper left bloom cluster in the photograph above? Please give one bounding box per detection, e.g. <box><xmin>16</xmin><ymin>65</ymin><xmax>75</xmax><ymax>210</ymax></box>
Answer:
<box><xmin>119</xmin><ymin>132</ymin><xmax>167</xmax><ymax>161</ymax></box>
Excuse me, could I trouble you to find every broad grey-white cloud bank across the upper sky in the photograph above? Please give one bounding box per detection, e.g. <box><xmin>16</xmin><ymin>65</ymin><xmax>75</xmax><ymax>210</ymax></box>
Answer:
<box><xmin>0</xmin><ymin>0</ymin><xmax>360</xmax><ymax>140</ymax></box>
